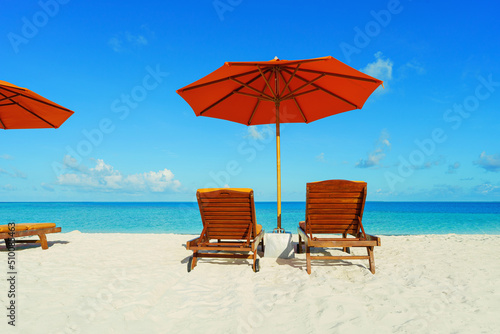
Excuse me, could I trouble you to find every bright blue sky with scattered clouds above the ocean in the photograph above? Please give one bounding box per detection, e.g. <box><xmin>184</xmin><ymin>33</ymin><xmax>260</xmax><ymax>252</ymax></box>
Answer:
<box><xmin>0</xmin><ymin>0</ymin><xmax>500</xmax><ymax>201</ymax></box>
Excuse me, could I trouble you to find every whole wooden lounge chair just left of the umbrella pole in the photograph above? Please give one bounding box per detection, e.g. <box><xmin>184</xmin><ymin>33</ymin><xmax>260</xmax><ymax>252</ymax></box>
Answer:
<box><xmin>186</xmin><ymin>188</ymin><xmax>264</xmax><ymax>272</ymax></box>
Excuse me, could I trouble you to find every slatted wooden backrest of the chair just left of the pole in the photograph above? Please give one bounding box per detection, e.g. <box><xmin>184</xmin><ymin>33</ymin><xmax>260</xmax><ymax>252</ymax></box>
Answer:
<box><xmin>196</xmin><ymin>188</ymin><xmax>257</xmax><ymax>242</ymax></box>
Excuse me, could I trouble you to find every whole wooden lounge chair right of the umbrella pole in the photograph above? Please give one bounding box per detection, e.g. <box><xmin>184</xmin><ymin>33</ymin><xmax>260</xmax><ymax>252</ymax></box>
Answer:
<box><xmin>297</xmin><ymin>180</ymin><xmax>380</xmax><ymax>274</ymax></box>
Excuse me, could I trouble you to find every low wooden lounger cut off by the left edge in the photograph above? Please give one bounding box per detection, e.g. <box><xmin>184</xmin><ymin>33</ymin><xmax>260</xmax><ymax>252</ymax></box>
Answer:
<box><xmin>0</xmin><ymin>223</ymin><xmax>61</xmax><ymax>249</ymax></box>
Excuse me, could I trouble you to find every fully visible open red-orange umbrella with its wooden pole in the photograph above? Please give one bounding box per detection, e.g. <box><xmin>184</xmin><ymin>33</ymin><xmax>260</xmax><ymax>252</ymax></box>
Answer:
<box><xmin>177</xmin><ymin>57</ymin><xmax>382</xmax><ymax>231</ymax></box>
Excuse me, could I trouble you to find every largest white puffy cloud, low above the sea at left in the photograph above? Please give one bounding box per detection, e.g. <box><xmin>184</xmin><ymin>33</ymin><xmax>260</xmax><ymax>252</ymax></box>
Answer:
<box><xmin>57</xmin><ymin>158</ymin><xmax>181</xmax><ymax>192</ymax></box>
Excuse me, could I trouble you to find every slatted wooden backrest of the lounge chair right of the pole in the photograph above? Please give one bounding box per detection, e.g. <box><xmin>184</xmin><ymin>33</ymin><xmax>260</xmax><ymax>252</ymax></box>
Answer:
<box><xmin>305</xmin><ymin>180</ymin><xmax>366</xmax><ymax>238</ymax></box>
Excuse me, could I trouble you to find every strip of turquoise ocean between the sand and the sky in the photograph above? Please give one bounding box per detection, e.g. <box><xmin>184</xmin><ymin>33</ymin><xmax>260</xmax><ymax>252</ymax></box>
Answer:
<box><xmin>0</xmin><ymin>202</ymin><xmax>500</xmax><ymax>235</ymax></box>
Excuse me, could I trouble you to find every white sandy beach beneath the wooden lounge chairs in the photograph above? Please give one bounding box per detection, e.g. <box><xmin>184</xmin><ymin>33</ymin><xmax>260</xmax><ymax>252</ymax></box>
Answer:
<box><xmin>0</xmin><ymin>232</ymin><xmax>500</xmax><ymax>333</ymax></box>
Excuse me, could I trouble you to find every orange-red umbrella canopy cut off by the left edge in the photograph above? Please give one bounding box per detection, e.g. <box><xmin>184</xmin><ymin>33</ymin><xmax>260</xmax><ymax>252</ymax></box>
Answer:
<box><xmin>0</xmin><ymin>80</ymin><xmax>73</xmax><ymax>130</ymax></box>
